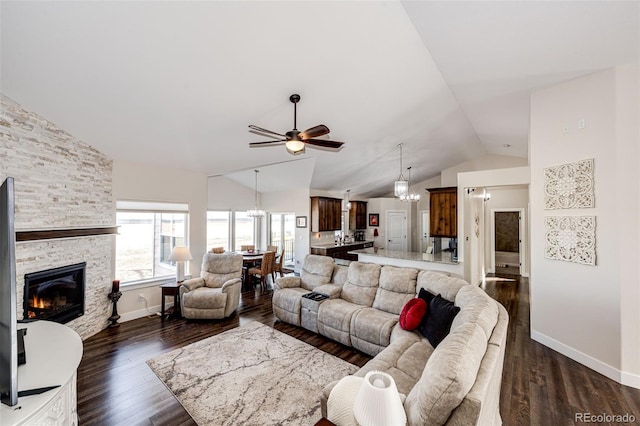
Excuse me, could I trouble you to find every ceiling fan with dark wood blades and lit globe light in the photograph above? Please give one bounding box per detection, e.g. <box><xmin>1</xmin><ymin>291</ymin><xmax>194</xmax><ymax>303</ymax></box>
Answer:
<box><xmin>249</xmin><ymin>94</ymin><xmax>344</xmax><ymax>155</ymax></box>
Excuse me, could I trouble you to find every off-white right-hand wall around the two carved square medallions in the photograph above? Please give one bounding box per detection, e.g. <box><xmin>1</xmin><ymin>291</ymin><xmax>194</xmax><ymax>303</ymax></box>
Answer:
<box><xmin>530</xmin><ymin>66</ymin><xmax>640</xmax><ymax>387</ymax></box>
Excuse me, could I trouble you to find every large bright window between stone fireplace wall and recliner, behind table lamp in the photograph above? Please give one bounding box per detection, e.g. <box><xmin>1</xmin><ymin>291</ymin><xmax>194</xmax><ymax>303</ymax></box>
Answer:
<box><xmin>116</xmin><ymin>201</ymin><xmax>189</xmax><ymax>283</ymax></box>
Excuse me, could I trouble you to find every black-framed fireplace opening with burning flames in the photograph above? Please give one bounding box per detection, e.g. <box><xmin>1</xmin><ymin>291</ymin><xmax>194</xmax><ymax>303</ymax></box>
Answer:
<box><xmin>24</xmin><ymin>262</ymin><xmax>87</xmax><ymax>324</ymax></box>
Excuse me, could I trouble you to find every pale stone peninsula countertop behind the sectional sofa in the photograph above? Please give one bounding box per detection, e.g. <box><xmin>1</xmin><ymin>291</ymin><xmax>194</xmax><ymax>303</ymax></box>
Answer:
<box><xmin>348</xmin><ymin>247</ymin><xmax>464</xmax><ymax>278</ymax></box>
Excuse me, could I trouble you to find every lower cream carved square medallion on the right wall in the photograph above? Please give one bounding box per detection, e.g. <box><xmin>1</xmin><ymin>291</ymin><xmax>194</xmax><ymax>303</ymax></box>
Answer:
<box><xmin>544</xmin><ymin>216</ymin><xmax>596</xmax><ymax>265</ymax></box>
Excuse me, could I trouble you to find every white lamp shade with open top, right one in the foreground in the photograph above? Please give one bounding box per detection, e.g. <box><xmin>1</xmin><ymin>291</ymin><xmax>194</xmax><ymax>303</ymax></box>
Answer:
<box><xmin>353</xmin><ymin>371</ymin><xmax>407</xmax><ymax>426</ymax></box>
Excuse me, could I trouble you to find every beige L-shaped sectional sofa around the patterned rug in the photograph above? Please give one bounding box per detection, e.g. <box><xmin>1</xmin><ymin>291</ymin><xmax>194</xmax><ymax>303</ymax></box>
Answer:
<box><xmin>273</xmin><ymin>255</ymin><xmax>508</xmax><ymax>425</ymax></box>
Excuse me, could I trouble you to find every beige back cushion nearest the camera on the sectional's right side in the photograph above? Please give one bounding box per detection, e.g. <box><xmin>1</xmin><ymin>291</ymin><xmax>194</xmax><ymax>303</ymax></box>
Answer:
<box><xmin>404</xmin><ymin>323</ymin><xmax>487</xmax><ymax>425</ymax></box>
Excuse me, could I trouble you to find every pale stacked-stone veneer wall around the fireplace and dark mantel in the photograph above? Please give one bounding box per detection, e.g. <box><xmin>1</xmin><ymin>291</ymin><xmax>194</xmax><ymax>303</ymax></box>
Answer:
<box><xmin>0</xmin><ymin>95</ymin><xmax>115</xmax><ymax>339</ymax></box>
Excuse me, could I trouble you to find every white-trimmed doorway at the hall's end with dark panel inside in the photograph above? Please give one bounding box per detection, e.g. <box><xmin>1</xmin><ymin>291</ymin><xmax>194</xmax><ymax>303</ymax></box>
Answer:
<box><xmin>490</xmin><ymin>209</ymin><xmax>525</xmax><ymax>275</ymax></box>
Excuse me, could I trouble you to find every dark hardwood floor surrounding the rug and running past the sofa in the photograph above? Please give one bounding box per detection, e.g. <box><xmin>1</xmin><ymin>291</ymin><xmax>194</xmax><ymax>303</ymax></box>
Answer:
<box><xmin>78</xmin><ymin>276</ymin><xmax>640</xmax><ymax>426</ymax></box>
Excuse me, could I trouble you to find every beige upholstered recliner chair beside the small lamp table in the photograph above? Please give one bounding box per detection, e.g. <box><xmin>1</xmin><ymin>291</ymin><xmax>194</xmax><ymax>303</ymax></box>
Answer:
<box><xmin>180</xmin><ymin>253</ymin><xmax>242</xmax><ymax>319</ymax></box>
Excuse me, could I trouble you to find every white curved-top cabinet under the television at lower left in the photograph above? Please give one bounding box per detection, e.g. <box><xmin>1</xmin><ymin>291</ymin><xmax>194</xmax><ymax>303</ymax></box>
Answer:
<box><xmin>0</xmin><ymin>321</ymin><xmax>82</xmax><ymax>426</ymax></box>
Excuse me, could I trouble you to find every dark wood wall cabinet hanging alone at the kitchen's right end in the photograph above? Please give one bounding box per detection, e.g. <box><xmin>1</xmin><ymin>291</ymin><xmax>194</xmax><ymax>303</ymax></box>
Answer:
<box><xmin>427</xmin><ymin>186</ymin><xmax>458</xmax><ymax>238</ymax></box>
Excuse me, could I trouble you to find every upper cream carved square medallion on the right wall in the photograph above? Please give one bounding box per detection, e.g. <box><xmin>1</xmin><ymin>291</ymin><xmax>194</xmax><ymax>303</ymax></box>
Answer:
<box><xmin>544</xmin><ymin>158</ymin><xmax>595</xmax><ymax>210</ymax></box>
